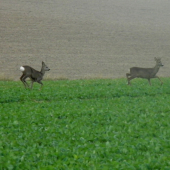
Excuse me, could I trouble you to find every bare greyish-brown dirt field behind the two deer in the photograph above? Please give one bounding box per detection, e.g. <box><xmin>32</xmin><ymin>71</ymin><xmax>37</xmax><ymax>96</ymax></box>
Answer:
<box><xmin>0</xmin><ymin>0</ymin><xmax>170</xmax><ymax>80</ymax></box>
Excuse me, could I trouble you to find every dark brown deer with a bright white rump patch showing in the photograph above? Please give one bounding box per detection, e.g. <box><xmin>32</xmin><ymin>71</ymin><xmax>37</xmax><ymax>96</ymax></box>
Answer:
<box><xmin>20</xmin><ymin>61</ymin><xmax>50</xmax><ymax>90</ymax></box>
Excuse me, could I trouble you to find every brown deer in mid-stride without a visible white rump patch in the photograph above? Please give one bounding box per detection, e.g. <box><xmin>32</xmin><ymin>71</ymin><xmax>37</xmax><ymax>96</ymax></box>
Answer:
<box><xmin>126</xmin><ymin>57</ymin><xmax>163</xmax><ymax>85</ymax></box>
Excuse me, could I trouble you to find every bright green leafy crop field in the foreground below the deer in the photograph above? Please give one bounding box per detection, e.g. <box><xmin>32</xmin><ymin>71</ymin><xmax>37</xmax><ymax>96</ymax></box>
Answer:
<box><xmin>0</xmin><ymin>78</ymin><xmax>170</xmax><ymax>170</ymax></box>
